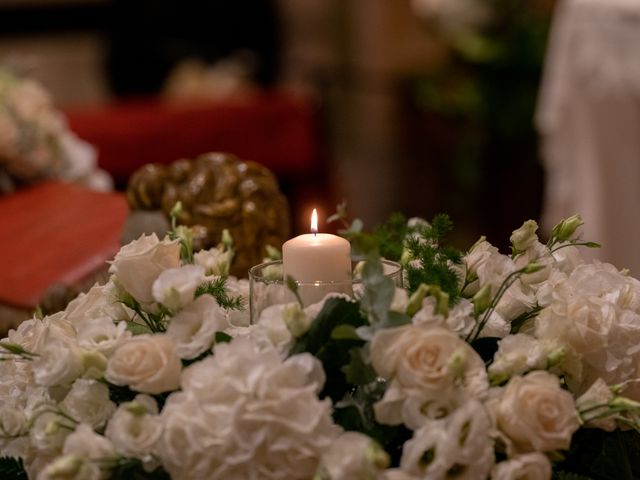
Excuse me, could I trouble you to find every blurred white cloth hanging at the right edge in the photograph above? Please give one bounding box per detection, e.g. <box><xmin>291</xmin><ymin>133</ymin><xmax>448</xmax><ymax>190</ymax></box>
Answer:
<box><xmin>536</xmin><ymin>0</ymin><xmax>640</xmax><ymax>276</ymax></box>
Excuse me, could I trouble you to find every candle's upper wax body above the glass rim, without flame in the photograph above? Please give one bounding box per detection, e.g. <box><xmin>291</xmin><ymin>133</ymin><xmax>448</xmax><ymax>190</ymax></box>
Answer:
<box><xmin>282</xmin><ymin>233</ymin><xmax>351</xmax><ymax>282</ymax></box>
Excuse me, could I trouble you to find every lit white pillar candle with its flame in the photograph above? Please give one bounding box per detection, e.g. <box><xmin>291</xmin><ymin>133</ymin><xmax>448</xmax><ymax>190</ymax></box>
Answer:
<box><xmin>282</xmin><ymin>208</ymin><xmax>351</xmax><ymax>305</ymax></box>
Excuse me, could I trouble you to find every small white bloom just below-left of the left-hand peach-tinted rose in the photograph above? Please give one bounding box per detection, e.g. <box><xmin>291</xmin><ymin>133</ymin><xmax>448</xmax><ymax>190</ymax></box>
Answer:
<box><xmin>60</xmin><ymin>379</ymin><xmax>116</xmax><ymax>429</ymax></box>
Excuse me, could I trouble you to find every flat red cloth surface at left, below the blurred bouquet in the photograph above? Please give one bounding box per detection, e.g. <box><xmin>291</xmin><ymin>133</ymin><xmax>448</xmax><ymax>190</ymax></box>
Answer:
<box><xmin>0</xmin><ymin>182</ymin><xmax>128</xmax><ymax>308</ymax></box>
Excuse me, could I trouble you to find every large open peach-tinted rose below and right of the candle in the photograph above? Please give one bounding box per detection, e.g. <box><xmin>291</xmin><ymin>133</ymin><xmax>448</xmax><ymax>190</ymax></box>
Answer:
<box><xmin>371</xmin><ymin>325</ymin><xmax>489</xmax><ymax>425</ymax></box>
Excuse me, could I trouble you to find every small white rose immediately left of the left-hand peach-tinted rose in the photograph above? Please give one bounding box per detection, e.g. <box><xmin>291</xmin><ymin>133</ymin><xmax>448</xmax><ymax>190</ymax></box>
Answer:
<box><xmin>32</xmin><ymin>341</ymin><xmax>84</xmax><ymax>387</ymax></box>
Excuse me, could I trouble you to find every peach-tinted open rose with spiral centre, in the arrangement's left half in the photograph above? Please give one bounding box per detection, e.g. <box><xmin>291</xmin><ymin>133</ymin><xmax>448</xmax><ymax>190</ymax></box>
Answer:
<box><xmin>105</xmin><ymin>334</ymin><xmax>182</xmax><ymax>394</ymax></box>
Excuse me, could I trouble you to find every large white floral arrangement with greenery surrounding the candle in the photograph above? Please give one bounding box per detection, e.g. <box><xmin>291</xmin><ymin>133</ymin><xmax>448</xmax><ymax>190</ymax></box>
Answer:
<box><xmin>0</xmin><ymin>207</ymin><xmax>640</xmax><ymax>480</ymax></box>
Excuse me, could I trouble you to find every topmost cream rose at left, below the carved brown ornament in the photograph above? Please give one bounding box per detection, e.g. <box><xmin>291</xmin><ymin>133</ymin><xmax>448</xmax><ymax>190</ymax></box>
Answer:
<box><xmin>109</xmin><ymin>233</ymin><xmax>180</xmax><ymax>304</ymax></box>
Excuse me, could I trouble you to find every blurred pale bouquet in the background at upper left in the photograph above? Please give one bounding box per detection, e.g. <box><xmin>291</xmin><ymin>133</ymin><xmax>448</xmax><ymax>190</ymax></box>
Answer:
<box><xmin>0</xmin><ymin>66</ymin><xmax>112</xmax><ymax>194</ymax></box>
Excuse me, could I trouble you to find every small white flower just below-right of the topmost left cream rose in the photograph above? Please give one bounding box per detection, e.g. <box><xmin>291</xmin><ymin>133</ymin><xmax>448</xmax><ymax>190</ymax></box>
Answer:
<box><xmin>151</xmin><ymin>265</ymin><xmax>205</xmax><ymax>312</ymax></box>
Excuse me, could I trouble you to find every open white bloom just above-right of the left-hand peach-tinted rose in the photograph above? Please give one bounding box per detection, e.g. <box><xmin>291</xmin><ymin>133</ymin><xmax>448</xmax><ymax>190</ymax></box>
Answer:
<box><xmin>167</xmin><ymin>295</ymin><xmax>229</xmax><ymax>359</ymax></box>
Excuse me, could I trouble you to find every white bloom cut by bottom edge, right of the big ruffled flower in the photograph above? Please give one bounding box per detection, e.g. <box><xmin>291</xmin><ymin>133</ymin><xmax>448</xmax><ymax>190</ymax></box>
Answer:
<box><xmin>316</xmin><ymin>432</ymin><xmax>389</xmax><ymax>480</ymax></box>
